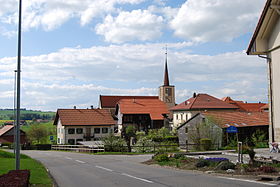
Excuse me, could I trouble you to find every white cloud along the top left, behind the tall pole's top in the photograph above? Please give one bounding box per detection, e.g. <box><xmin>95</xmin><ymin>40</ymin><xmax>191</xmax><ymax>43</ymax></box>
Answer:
<box><xmin>0</xmin><ymin>0</ymin><xmax>145</xmax><ymax>31</ymax></box>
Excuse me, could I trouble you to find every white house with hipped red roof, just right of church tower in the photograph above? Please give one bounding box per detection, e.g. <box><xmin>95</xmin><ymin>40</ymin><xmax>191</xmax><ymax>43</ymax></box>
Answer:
<box><xmin>170</xmin><ymin>93</ymin><xmax>238</xmax><ymax>129</ymax></box>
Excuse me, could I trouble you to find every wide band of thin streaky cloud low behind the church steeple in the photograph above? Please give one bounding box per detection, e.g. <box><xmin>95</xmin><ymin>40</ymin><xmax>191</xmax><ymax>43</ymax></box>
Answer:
<box><xmin>0</xmin><ymin>42</ymin><xmax>267</xmax><ymax>110</ymax></box>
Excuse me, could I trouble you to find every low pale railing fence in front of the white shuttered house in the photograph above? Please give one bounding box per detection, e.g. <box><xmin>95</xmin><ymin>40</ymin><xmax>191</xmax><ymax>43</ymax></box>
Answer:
<box><xmin>52</xmin><ymin>145</ymin><xmax>105</xmax><ymax>153</ymax></box>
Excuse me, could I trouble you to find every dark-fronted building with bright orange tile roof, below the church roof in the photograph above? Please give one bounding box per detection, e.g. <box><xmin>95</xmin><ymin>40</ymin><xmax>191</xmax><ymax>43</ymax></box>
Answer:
<box><xmin>115</xmin><ymin>98</ymin><xmax>169</xmax><ymax>132</ymax></box>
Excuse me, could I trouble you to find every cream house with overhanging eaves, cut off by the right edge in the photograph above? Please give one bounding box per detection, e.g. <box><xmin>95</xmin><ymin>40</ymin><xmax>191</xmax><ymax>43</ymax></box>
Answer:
<box><xmin>247</xmin><ymin>0</ymin><xmax>280</xmax><ymax>142</ymax></box>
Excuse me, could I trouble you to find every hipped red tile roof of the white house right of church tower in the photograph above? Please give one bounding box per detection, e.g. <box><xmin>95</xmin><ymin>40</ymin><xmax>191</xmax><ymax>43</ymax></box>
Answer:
<box><xmin>170</xmin><ymin>94</ymin><xmax>238</xmax><ymax>111</ymax></box>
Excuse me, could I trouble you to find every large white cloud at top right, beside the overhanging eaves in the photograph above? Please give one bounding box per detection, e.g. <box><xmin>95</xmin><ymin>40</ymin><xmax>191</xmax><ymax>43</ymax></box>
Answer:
<box><xmin>170</xmin><ymin>0</ymin><xmax>264</xmax><ymax>42</ymax></box>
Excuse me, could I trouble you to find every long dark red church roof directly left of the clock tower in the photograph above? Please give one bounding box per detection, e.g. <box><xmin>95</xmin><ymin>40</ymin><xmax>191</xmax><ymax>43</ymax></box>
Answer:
<box><xmin>99</xmin><ymin>95</ymin><xmax>158</xmax><ymax>108</ymax></box>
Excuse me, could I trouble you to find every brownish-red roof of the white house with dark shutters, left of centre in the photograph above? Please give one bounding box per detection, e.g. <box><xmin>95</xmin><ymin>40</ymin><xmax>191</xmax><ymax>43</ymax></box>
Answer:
<box><xmin>54</xmin><ymin>109</ymin><xmax>115</xmax><ymax>126</ymax></box>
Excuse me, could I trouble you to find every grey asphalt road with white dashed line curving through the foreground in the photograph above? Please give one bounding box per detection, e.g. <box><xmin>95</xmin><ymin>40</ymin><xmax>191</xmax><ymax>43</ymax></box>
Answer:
<box><xmin>22</xmin><ymin>151</ymin><xmax>278</xmax><ymax>187</ymax></box>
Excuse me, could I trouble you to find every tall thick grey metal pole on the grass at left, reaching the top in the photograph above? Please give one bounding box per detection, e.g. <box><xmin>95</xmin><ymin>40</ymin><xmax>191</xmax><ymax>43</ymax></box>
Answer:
<box><xmin>16</xmin><ymin>0</ymin><xmax>22</xmax><ymax>170</ymax></box>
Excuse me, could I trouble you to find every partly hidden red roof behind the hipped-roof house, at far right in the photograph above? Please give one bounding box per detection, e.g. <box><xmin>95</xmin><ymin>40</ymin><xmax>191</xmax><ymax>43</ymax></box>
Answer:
<box><xmin>222</xmin><ymin>97</ymin><xmax>265</xmax><ymax>112</ymax></box>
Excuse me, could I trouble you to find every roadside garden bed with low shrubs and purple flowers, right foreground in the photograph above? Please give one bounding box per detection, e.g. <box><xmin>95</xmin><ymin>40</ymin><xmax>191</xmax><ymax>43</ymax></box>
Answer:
<box><xmin>143</xmin><ymin>153</ymin><xmax>280</xmax><ymax>178</ymax></box>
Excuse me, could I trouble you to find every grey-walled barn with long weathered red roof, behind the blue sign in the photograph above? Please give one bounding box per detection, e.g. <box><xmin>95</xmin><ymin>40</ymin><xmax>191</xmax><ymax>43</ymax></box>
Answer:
<box><xmin>177</xmin><ymin>111</ymin><xmax>269</xmax><ymax>149</ymax></box>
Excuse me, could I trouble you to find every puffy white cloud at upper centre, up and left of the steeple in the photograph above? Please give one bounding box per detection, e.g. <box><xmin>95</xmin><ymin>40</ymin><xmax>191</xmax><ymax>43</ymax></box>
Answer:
<box><xmin>96</xmin><ymin>9</ymin><xmax>163</xmax><ymax>43</ymax></box>
